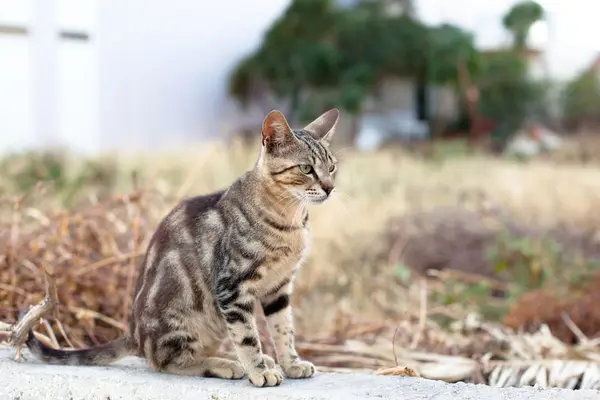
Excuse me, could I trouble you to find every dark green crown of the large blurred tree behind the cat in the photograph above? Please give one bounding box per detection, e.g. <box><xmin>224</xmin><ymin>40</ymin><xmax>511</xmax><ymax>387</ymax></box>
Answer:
<box><xmin>229</xmin><ymin>0</ymin><xmax>477</xmax><ymax>119</ymax></box>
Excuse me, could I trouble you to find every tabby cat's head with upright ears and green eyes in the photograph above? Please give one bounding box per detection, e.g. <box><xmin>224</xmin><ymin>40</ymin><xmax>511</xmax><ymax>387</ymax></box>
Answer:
<box><xmin>259</xmin><ymin>109</ymin><xmax>340</xmax><ymax>204</ymax></box>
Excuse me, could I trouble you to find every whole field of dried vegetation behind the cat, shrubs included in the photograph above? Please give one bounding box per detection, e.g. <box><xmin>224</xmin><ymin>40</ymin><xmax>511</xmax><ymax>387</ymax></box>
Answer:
<box><xmin>0</xmin><ymin>141</ymin><xmax>600</xmax><ymax>388</ymax></box>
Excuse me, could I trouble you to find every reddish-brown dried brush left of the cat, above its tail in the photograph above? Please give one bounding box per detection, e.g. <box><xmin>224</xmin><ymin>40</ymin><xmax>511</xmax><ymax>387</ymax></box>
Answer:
<box><xmin>0</xmin><ymin>188</ymin><xmax>156</xmax><ymax>347</ymax></box>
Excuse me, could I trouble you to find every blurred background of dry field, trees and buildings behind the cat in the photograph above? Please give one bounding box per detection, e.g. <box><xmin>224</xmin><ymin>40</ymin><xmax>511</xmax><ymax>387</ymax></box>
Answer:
<box><xmin>0</xmin><ymin>0</ymin><xmax>600</xmax><ymax>388</ymax></box>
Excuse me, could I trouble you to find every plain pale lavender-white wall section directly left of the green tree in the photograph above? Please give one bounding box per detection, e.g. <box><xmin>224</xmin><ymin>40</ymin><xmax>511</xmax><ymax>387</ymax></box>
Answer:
<box><xmin>99</xmin><ymin>0</ymin><xmax>287</xmax><ymax>152</ymax></box>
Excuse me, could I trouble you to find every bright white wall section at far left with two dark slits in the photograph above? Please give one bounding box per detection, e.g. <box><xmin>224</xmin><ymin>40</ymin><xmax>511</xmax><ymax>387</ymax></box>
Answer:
<box><xmin>0</xmin><ymin>0</ymin><xmax>98</xmax><ymax>152</ymax></box>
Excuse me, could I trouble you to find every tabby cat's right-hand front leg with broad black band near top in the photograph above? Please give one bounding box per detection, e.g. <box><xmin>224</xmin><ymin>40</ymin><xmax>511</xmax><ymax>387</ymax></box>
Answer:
<box><xmin>261</xmin><ymin>283</ymin><xmax>317</xmax><ymax>379</ymax></box>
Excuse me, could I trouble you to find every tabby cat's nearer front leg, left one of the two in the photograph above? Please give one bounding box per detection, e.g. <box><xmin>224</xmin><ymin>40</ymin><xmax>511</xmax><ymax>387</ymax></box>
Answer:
<box><xmin>216</xmin><ymin>276</ymin><xmax>283</xmax><ymax>387</ymax></box>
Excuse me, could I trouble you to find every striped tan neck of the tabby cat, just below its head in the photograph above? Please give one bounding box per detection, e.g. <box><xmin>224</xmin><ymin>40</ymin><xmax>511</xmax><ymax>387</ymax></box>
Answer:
<box><xmin>241</xmin><ymin>170</ymin><xmax>308</xmax><ymax>227</ymax></box>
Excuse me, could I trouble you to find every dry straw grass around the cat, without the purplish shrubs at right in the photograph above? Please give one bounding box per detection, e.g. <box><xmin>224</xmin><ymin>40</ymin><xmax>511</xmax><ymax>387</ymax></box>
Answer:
<box><xmin>0</xmin><ymin>137</ymin><xmax>600</xmax><ymax>388</ymax></box>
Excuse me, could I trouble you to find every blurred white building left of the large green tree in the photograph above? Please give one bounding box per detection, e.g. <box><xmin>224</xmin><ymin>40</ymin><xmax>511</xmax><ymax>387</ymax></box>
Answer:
<box><xmin>0</xmin><ymin>0</ymin><xmax>287</xmax><ymax>152</ymax></box>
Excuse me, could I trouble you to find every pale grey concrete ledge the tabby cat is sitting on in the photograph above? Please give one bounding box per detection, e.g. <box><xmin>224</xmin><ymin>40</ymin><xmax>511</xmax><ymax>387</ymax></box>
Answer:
<box><xmin>0</xmin><ymin>349</ymin><xmax>600</xmax><ymax>400</ymax></box>
